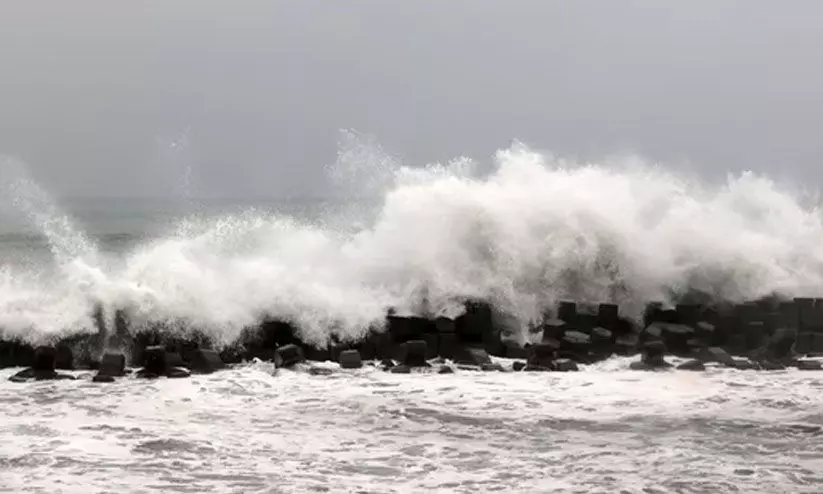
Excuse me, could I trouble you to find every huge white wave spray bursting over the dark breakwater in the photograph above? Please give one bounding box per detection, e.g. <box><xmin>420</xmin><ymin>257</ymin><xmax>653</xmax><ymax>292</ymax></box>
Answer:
<box><xmin>0</xmin><ymin>134</ymin><xmax>823</xmax><ymax>341</ymax></box>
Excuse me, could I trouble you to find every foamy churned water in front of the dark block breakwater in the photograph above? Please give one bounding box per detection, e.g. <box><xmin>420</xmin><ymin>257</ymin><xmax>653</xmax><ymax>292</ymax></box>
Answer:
<box><xmin>0</xmin><ymin>359</ymin><xmax>823</xmax><ymax>493</ymax></box>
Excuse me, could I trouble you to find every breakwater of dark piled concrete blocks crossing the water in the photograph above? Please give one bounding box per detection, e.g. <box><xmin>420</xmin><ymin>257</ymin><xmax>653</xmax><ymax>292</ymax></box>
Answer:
<box><xmin>0</xmin><ymin>298</ymin><xmax>823</xmax><ymax>382</ymax></box>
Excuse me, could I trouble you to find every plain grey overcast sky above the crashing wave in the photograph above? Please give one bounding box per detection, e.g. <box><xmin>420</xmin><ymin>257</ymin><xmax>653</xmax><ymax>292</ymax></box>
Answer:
<box><xmin>0</xmin><ymin>0</ymin><xmax>823</xmax><ymax>196</ymax></box>
